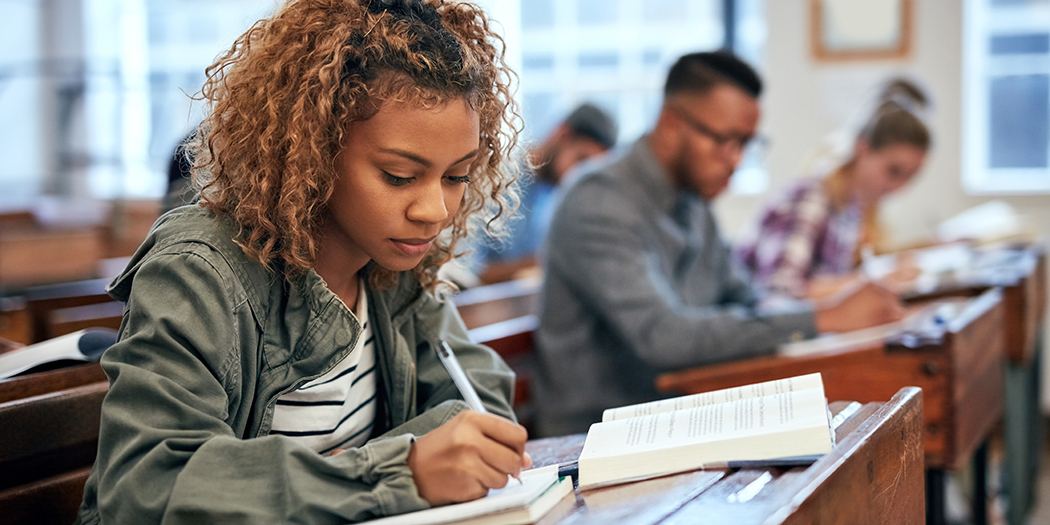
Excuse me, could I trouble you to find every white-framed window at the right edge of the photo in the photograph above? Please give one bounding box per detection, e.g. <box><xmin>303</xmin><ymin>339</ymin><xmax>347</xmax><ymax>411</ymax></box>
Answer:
<box><xmin>963</xmin><ymin>0</ymin><xmax>1050</xmax><ymax>194</ymax></box>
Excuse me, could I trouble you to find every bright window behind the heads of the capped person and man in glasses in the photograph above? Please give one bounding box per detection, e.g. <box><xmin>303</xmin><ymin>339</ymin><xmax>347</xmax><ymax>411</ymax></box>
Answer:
<box><xmin>518</xmin><ymin>0</ymin><xmax>769</xmax><ymax>193</ymax></box>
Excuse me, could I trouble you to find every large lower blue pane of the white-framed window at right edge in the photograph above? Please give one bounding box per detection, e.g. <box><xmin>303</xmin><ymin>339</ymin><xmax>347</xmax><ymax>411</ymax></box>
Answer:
<box><xmin>989</xmin><ymin>75</ymin><xmax>1050</xmax><ymax>168</ymax></box>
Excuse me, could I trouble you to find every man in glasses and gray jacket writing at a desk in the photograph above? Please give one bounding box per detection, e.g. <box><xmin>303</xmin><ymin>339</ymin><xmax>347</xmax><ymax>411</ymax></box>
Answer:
<box><xmin>536</xmin><ymin>51</ymin><xmax>901</xmax><ymax>436</ymax></box>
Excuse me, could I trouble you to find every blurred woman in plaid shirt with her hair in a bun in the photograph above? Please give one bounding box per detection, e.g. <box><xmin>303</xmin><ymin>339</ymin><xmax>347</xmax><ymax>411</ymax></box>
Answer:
<box><xmin>734</xmin><ymin>79</ymin><xmax>930</xmax><ymax>298</ymax></box>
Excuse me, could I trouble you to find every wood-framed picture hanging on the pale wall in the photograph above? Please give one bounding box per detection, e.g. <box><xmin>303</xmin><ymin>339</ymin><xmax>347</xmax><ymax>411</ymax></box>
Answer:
<box><xmin>810</xmin><ymin>0</ymin><xmax>914</xmax><ymax>61</ymax></box>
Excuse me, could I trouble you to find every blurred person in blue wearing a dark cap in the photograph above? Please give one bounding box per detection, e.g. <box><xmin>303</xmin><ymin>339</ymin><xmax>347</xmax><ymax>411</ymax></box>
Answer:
<box><xmin>474</xmin><ymin>103</ymin><xmax>616</xmax><ymax>285</ymax></box>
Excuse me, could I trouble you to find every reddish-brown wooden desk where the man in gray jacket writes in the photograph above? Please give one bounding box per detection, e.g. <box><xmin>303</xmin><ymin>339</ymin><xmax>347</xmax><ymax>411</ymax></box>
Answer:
<box><xmin>656</xmin><ymin>289</ymin><xmax>1004</xmax><ymax>522</ymax></box>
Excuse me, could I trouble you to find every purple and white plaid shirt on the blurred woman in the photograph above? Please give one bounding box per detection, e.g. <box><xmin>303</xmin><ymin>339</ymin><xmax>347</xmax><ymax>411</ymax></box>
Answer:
<box><xmin>734</xmin><ymin>177</ymin><xmax>861</xmax><ymax>298</ymax></box>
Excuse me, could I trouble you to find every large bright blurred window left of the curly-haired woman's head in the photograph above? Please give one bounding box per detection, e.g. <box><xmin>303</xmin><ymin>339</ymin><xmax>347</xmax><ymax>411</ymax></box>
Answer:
<box><xmin>0</xmin><ymin>0</ymin><xmax>275</xmax><ymax>206</ymax></box>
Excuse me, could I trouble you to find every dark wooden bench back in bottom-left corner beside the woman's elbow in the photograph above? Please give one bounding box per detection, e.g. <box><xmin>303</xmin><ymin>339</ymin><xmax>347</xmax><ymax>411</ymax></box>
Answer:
<box><xmin>0</xmin><ymin>381</ymin><xmax>109</xmax><ymax>525</ymax></box>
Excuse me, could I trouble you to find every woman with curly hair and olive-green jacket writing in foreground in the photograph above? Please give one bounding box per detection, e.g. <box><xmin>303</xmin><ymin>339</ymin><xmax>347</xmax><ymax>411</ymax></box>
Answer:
<box><xmin>78</xmin><ymin>0</ymin><xmax>529</xmax><ymax>524</ymax></box>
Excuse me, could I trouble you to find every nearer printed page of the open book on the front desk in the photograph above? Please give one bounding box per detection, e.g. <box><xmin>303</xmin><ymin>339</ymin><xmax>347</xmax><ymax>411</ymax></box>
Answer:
<box><xmin>580</xmin><ymin>386</ymin><xmax>831</xmax><ymax>459</ymax></box>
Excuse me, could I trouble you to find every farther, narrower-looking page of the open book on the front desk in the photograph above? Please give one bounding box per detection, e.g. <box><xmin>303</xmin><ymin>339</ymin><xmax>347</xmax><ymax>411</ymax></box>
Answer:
<box><xmin>602</xmin><ymin>374</ymin><xmax>824</xmax><ymax>422</ymax></box>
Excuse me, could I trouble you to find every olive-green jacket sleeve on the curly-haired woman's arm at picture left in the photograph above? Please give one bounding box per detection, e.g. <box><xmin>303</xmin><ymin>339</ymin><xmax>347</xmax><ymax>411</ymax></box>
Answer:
<box><xmin>89</xmin><ymin>251</ymin><xmax>427</xmax><ymax>524</ymax></box>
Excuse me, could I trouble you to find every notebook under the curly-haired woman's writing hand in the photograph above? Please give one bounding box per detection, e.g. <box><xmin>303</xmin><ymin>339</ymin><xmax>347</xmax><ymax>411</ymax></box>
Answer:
<box><xmin>369</xmin><ymin>465</ymin><xmax>572</xmax><ymax>525</ymax></box>
